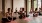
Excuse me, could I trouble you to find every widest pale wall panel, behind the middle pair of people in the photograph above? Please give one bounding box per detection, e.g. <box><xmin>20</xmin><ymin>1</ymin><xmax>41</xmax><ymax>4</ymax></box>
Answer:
<box><xmin>13</xmin><ymin>0</ymin><xmax>24</xmax><ymax>12</ymax></box>
